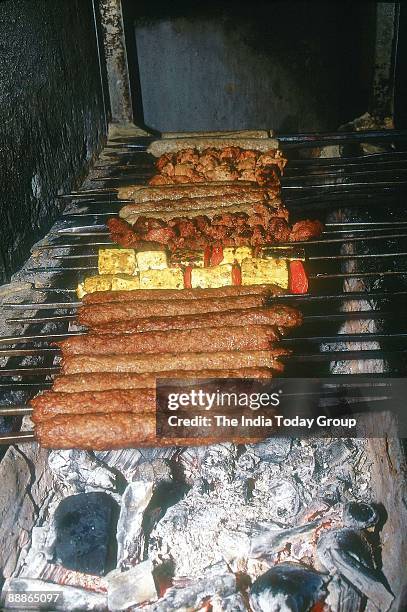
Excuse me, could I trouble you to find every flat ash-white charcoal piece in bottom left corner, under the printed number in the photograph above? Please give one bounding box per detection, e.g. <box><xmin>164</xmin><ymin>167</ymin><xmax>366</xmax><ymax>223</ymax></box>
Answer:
<box><xmin>0</xmin><ymin>578</ymin><xmax>107</xmax><ymax>612</ymax></box>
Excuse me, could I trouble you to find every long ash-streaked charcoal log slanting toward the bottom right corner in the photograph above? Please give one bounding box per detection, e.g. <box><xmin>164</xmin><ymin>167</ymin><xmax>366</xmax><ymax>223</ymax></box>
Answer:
<box><xmin>317</xmin><ymin>528</ymin><xmax>394</xmax><ymax>612</ymax></box>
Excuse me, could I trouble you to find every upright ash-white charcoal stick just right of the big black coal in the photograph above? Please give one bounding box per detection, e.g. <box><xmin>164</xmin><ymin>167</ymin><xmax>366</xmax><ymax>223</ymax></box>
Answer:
<box><xmin>116</xmin><ymin>481</ymin><xmax>154</xmax><ymax>568</ymax></box>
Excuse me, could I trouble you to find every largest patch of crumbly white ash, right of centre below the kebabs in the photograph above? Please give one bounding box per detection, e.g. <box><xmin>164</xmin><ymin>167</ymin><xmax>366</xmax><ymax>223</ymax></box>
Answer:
<box><xmin>149</xmin><ymin>439</ymin><xmax>369</xmax><ymax>576</ymax></box>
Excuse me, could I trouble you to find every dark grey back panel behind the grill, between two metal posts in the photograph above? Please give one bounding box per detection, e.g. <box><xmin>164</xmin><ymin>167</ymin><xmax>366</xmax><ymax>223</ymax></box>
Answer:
<box><xmin>128</xmin><ymin>0</ymin><xmax>376</xmax><ymax>132</ymax></box>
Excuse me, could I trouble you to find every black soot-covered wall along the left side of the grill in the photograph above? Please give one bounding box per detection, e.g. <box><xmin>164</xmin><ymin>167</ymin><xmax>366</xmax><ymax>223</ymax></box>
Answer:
<box><xmin>0</xmin><ymin>0</ymin><xmax>106</xmax><ymax>283</ymax></box>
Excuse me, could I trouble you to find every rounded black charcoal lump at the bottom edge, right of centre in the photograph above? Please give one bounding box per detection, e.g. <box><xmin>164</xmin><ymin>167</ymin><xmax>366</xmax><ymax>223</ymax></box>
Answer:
<box><xmin>250</xmin><ymin>563</ymin><xmax>327</xmax><ymax>612</ymax></box>
